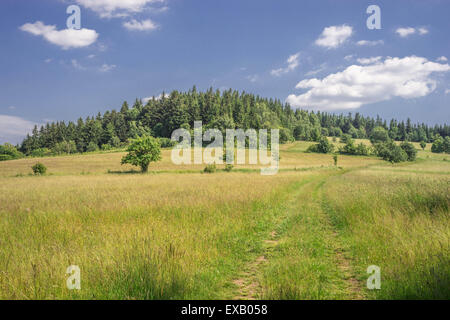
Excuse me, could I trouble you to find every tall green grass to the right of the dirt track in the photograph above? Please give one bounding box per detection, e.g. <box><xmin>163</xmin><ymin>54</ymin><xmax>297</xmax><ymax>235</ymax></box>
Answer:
<box><xmin>325</xmin><ymin>165</ymin><xmax>450</xmax><ymax>299</ymax></box>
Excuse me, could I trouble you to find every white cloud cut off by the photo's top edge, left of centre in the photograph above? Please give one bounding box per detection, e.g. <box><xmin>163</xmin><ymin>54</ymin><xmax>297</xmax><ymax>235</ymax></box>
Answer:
<box><xmin>76</xmin><ymin>0</ymin><xmax>167</xmax><ymax>18</ymax></box>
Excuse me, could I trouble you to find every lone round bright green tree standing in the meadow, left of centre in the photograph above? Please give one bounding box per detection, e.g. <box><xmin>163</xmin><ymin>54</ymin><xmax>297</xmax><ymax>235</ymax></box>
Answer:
<box><xmin>122</xmin><ymin>136</ymin><xmax>161</xmax><ymax>173</ymax></box>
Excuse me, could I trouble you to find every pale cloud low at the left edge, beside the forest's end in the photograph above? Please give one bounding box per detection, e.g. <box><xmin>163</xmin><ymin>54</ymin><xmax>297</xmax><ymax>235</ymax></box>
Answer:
<box><xmin>0</xmin><ymin>114</ymin><xmax>37</xmax><ymax>144</ymax></box>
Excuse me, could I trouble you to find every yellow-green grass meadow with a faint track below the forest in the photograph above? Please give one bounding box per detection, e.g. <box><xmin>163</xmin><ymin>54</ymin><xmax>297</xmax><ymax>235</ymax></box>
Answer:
<box><xmin>0</xmin><ymin>142</ymin><xmax>450</xmax><ymax>299</ymax></box>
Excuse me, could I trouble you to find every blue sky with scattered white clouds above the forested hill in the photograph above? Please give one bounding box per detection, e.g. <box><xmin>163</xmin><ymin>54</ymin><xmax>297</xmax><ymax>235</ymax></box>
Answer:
<box><xmin>0</xmin><ymin>0</ymin><xmax>450</xmax><ymax>144</ymax></box>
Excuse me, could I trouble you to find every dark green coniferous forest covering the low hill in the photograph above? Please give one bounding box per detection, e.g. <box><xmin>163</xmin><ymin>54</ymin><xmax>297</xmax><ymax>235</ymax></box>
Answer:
<box><xmin>19</xmin><ymin>86</ymin><xmax>450</xmax><ymax>155</ymax></box>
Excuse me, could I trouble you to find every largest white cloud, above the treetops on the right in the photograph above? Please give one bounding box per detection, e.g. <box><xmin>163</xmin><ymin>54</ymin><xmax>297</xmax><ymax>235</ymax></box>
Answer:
<box><xmin>286</xmin><ymin>56</ymin><xmax>450</xmax><ymax>110</ymax></box>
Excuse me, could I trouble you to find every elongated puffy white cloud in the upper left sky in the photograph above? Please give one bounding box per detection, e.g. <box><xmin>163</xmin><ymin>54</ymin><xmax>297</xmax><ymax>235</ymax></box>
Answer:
<box><xmin>19</xmin><ymin>21</ymin><xmax>98</xmax><ymax>50</ymax></box>
